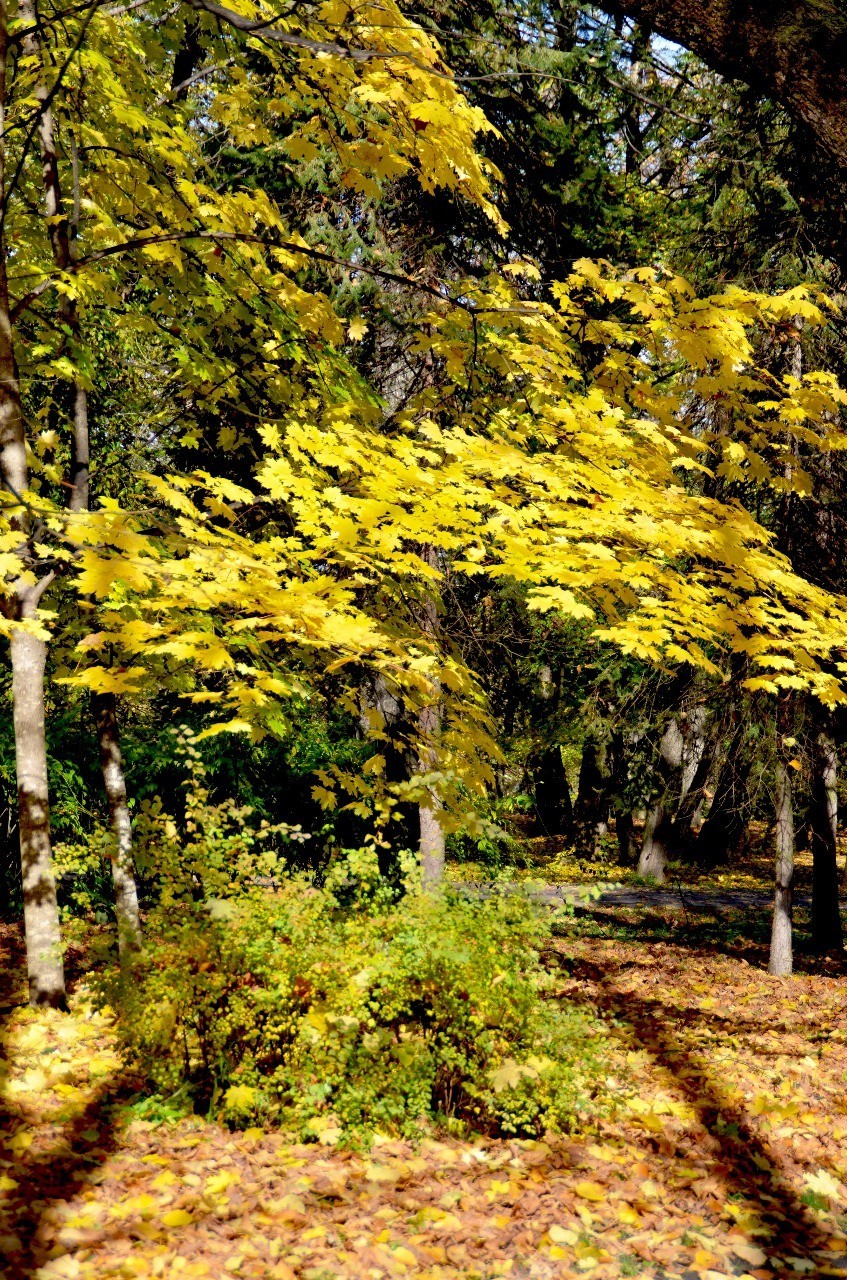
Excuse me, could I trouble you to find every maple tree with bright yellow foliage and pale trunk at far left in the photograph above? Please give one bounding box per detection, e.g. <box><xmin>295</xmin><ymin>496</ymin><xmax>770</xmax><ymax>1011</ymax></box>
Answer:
<box><xmin>4</xmin><ymin>6</ymin><xmax>842</xmax><ymax>1000</ymax></box>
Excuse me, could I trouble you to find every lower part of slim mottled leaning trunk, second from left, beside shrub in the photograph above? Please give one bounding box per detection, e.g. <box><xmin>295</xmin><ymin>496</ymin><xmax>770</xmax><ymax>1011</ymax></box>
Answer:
<box><xmin>92</xmin><ymin>694</ymin><xmax>141</xmax><ymax>956</ymax></box>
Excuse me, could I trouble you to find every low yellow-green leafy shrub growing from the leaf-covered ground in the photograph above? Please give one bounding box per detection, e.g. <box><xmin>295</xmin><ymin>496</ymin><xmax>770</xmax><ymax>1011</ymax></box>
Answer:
<box><xmin>106</xmin><ymin>878</ymin><xmax>611</xmax><ymax>1143</ymax></box>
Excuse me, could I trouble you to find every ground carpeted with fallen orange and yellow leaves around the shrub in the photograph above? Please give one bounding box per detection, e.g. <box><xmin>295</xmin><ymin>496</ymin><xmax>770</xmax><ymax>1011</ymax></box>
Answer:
<box><xmin>0</xmin><ymin>906</ymin><xmax>847</xmax><ymax>1280</ymax></box>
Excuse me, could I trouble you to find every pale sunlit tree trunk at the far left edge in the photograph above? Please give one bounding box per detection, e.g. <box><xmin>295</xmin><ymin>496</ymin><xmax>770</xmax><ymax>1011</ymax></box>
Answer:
<box><xmin>0</xmin><ymin>5</ymin><xmax>65</xmax><ymax>1006</ymax></box>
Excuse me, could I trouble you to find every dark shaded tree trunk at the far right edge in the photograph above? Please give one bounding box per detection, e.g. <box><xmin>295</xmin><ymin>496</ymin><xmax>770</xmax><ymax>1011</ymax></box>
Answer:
<box><xmin>809</xmin><ymin>732</ymin><xmax>843</xmax><ymax>952</ymax></box>
